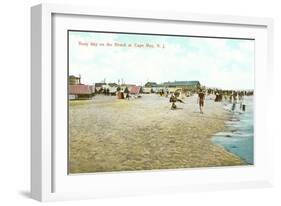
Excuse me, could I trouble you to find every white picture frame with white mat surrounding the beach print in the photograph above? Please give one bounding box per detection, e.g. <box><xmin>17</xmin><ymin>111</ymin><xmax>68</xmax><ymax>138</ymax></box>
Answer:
<box><xmin>31</xmin><ymin>4</ymin><xmax>273</xmax><ymax>201</ymax></box>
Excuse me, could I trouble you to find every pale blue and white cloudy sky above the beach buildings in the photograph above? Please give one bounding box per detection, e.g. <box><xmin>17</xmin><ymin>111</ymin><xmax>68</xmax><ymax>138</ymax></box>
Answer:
<box><xmin>69</xmin><ymin>32</ymin><xmax>254</xmax><ymax>89</ymax></box>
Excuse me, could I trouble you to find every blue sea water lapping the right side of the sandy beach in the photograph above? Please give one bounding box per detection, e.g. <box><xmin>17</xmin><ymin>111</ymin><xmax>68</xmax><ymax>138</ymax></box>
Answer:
<box><xmin>212</xmin><ymin>96</ymin><xmax>254</xmax><ymax>164</ymax></box>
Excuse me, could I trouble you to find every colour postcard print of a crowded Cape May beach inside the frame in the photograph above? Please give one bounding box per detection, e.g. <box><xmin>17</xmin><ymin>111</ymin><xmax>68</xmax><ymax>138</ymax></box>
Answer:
<box><xmin>67</xmin><ymin>30</ymin><xmax>255</xmax><ymax>174</ymax></box>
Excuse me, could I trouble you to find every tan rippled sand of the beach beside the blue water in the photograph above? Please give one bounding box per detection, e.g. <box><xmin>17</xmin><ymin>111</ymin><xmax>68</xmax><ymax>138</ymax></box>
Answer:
<box><xmin>69</xmin><ymin>94</ymin><xmax>245</xmax><ymax>173</ymax></box>
